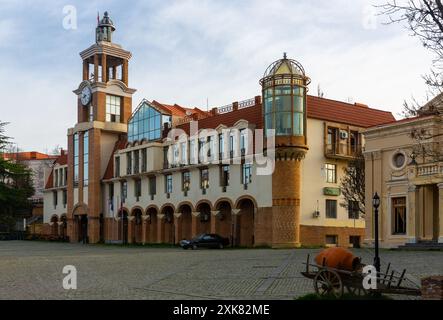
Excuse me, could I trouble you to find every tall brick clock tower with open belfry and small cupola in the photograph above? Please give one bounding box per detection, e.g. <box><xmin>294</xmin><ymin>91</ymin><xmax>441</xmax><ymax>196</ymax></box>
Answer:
<box><xmin>67</xmin><ymin>12</ymin><xmax>136</xmax><ymax>243</ymax></box>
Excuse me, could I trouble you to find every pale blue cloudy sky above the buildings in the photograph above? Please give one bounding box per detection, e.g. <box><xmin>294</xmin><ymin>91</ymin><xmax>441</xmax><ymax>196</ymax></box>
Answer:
<box><xmin>0</xmin><ymin>0</ymin><xmax>438</xmax><ymax>151</ymax></box>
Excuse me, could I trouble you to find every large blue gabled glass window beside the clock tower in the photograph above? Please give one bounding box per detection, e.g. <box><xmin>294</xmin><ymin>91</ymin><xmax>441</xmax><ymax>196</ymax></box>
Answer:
<box><xmin>128</xmin><ymin>102</ymin><xmax>164</xmax><ymax>142</ymax></box>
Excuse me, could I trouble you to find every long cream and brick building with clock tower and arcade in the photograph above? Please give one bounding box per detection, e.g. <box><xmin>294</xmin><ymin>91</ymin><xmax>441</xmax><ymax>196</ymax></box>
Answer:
<box><xmin>41</xmin><ymin>13</ymin><xmax>394</xmax><ymax>247</ymax></box>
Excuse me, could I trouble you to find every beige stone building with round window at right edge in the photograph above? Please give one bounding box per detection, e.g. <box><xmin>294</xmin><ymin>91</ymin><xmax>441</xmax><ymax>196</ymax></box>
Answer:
<box><xmin>364</xmin><ymin>95</ymin><xmax>443</xmax><ymax>247</ymax></box>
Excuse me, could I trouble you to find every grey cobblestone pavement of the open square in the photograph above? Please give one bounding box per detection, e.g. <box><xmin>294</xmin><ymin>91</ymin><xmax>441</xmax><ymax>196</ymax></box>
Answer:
<box><xmin>0</xmin><ymin>241</ymin><xmax>443</xmax><ymax>300</ymax></box>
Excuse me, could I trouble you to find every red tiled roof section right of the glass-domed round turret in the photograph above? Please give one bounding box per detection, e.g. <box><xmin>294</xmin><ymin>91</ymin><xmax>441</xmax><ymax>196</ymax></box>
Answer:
<box><xmin>307</xmin><ymin>96</ymin><xmax>395</xmax><ymax>128</ymax></box>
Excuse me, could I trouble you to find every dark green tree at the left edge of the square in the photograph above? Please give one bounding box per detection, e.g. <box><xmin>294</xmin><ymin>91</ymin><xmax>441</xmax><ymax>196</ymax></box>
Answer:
<box><xmin>0</xmin><ymin>121</ymin><xmax>34</xmax><ymax>231</ymax></box>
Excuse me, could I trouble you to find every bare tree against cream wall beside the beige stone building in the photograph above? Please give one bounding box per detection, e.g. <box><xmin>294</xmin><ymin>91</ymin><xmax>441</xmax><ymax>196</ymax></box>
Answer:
<box><xmin>340</xmin><ymin>151</ymin><xmax>365</xmax><ymax>218</ymax></box>
